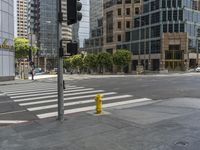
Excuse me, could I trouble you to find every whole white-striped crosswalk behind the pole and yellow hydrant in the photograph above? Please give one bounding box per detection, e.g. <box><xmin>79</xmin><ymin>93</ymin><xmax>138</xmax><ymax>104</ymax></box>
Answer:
<box><xmin>0</xmin><ymin>83</ymin><xmax>151</xmax><ymax>119</ymax></box>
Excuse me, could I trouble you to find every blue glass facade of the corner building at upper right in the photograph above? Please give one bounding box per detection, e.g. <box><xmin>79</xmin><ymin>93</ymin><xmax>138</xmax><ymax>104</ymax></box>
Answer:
<box><xmin>122</xmin><ymin>0</ymin><xmax>200</xmax><ymax>55</ymax></box>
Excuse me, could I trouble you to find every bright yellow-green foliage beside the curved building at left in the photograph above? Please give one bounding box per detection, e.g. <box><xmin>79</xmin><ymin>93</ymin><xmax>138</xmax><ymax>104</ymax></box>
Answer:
<box><xmin>14</xmin><ymin>38</ymin><xmax>30</xmax><ymax>58</ymax></box>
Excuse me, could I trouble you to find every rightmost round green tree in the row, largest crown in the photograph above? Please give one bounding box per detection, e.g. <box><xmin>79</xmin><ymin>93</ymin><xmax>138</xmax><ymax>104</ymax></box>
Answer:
<box><xmin>113</xmin><ymin>49</ymin><xmax>131</xmax><ymax>72</ymax></box>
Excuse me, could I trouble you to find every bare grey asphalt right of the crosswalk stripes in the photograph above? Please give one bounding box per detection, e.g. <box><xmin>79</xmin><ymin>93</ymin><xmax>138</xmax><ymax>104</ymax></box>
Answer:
<box><xmin>67</xmin><ymin>74</ymin><xmax>200</xmax><ymax>100</ymax></box>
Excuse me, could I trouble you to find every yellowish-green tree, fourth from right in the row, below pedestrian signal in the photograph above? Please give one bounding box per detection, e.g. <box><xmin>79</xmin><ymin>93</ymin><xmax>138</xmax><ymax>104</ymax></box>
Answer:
<box><xmin>71</xmin><ymin>54</ymin><xmax>83</xmax><ymax>72</ymax></box>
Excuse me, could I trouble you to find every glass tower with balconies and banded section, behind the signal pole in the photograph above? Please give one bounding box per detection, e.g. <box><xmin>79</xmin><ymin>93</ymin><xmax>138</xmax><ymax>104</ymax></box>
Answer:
<box><xmin>28</xmin><ymin>0</ymin><xmax>72</xmax><ymax>71</ymax></box>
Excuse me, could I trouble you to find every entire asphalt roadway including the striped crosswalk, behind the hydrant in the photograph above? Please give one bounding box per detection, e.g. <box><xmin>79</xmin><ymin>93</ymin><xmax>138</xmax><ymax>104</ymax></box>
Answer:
<box><xmin>0</xmin><ymin>74</ymin><xmax>200</xmax><ymax>126</ymax></box>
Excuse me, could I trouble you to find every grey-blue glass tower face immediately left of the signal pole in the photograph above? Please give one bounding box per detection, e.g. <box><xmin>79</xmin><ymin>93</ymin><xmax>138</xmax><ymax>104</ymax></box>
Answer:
<box><xmin>38</xmin><ymin>0</ymin><xmax>58</xmax><ymax>56</ymax></box>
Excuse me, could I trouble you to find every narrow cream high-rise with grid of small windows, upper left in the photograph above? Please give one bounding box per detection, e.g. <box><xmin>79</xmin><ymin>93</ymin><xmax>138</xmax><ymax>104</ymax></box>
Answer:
<box><xmin>17</xmin><ymin>0</ymin><xmax>28</xmax><ymax>38</ymax></box>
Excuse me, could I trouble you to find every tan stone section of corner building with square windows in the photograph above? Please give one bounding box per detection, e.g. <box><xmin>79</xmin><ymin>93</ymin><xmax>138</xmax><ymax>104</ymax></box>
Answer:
<box><xmin>103</xmin><ymin>0</ymin><xmax>140</xmax><ymax>54</ymax></box>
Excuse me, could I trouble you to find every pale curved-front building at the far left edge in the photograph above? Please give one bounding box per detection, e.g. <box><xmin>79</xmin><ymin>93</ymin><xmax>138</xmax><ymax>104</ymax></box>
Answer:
<box><xmin>0</xmin><ymin>0</ymin><xmax>15</xmax><ymax>81</ymax></box>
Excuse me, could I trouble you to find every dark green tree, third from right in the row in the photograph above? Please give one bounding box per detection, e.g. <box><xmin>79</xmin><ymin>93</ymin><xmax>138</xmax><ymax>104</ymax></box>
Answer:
<box><xmin>84</xmin><ymin>54</ymin><xmax>98</xmax><ymax>71</ymax></box>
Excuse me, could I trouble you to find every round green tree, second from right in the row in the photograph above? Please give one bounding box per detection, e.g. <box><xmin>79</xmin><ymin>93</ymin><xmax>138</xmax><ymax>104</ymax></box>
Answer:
<box><xmin>97</xmin><ymin>52</ymin><xmax>113</xmax><ymax>73</ymax></box>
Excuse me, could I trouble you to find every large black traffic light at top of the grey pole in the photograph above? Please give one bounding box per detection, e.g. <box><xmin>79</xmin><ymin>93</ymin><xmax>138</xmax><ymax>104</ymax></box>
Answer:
<box><xmin>67</xmin><ymin>0</ymin><xmax>82</xmax><ymax>25</ymax></box>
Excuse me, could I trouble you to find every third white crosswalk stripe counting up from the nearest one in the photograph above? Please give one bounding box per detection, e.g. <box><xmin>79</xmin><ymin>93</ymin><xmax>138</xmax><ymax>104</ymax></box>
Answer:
<box><xmin>19</xmin><ymin>92</ymin><xmax>117</xmax><ymax>106</ymax></box>
